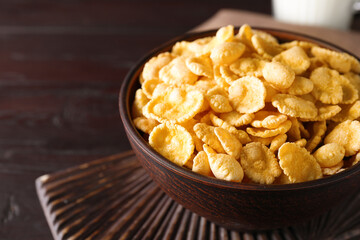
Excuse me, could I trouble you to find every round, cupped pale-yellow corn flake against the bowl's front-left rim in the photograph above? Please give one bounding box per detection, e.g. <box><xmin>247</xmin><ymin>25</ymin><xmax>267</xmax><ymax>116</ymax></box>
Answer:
<box><xmin>149</xmin><ymin>123</ymin><xmax>194</xmax><ymax>166</ymax></box>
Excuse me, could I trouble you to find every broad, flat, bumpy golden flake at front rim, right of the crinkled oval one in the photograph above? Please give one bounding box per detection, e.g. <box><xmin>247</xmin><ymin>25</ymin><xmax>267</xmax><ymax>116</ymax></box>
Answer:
<box><xmin>278</xmin><ymin>142</ymin><xmax>322</xmax><ymax>183</ymax></box>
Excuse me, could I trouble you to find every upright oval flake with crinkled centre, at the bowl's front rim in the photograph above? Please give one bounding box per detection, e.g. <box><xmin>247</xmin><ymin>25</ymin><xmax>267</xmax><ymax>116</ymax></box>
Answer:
<box><xmin>240</xmin><ymin>142</ymin><xmax>281</xmax><ymax>184</ymax></box>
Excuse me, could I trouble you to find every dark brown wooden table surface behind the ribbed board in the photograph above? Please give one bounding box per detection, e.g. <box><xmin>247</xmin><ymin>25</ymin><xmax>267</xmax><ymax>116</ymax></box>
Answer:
<box><xmin>0</xmin><ymin>0</ymin><xmax>360</xmax><ymax>240</ymax></box>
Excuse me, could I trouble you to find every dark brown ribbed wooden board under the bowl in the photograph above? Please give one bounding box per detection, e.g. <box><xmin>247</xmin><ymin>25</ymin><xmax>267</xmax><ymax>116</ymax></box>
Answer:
<box><xmin>36</xmin><ymin>152</ymin><xmax>360</xmax><ymax>240</ymax></box>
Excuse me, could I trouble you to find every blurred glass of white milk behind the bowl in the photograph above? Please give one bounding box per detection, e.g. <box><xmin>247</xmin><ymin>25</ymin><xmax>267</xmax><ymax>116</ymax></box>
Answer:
<box><xmin>272</xmin><ymin>0</ymin><xmax>360</xmax><ymax>30</ymax></box>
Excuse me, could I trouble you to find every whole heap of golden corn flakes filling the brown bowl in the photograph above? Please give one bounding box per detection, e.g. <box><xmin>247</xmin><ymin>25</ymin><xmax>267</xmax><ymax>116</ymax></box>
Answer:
<box><xmin>132</xmin><ymin>24</ymin><xmax>360</xmax><ymax>184</ymax></box>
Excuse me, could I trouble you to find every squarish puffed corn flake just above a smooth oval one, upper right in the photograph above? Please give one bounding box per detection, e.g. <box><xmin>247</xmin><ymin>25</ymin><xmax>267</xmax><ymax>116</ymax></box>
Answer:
<box><xmin>273</xmin><ymin>46</ymin><xmax>310</xmax><ymax>75</ymax></box>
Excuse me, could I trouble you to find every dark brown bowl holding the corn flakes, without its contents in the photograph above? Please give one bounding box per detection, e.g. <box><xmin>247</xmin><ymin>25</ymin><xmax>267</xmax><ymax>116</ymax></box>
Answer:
<box><xmin>119</xmin><ymin>28</ymin><xmax>360</xmax><ymax>230</ymax></box>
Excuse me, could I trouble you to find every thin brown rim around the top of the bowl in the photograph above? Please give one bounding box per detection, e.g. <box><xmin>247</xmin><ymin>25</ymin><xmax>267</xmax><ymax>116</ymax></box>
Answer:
<box><xmin>118</xmin><ymin>26</ymin><xmax>360</xmax><ymax>191</ymax></box>
